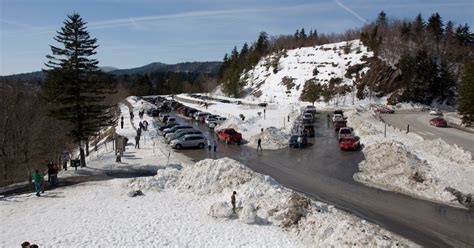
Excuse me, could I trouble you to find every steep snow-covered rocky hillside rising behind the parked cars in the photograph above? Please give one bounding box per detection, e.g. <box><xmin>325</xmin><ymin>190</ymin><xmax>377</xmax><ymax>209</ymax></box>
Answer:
<box><xmin>241</xmin><ymin>40</ymin><xmax>373</xmax><ymax>103</ymax></box>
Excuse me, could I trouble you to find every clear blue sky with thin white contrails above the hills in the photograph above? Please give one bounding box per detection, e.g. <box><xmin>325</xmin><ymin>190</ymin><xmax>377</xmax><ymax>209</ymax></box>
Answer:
<box><xmin>0</xmin><ymin>0</ymin><xmax>474</xmax><ymax>75</ymax></box>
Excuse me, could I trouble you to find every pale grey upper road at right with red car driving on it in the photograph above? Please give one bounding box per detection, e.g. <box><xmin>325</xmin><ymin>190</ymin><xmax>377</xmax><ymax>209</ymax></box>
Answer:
<box><xmin>382</xmin><ymin>112</ymin><xmax>474</xmax><ymax>155</ymax></box>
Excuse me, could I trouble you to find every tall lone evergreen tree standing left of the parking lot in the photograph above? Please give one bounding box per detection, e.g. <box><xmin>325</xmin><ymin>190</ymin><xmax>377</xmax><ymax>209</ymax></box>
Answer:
<box><xmin>43</xmin><ymin>13</ymin><xmax>115</xmax><ymax>166</ymax></box>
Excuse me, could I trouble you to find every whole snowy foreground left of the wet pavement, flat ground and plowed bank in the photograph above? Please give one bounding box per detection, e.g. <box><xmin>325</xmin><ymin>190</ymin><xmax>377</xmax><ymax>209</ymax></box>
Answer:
<box><xmin>0</xmin><ymin>98</ymin><xmax>415</xmax><ymax>247</ymax></box>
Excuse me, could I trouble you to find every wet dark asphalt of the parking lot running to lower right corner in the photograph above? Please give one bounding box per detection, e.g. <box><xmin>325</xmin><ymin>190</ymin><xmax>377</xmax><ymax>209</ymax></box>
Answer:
<box><xmin>161</xmin><ymin>111</ymin><xmax>474</xmax><ymax>247</ymax></box>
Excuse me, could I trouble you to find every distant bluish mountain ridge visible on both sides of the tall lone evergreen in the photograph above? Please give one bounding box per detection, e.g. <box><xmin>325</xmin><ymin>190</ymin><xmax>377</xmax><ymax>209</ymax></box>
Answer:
<box><xmin>0</xmin><ymin>61</ymin><xmax>222</xmax><ymax>81</ymax></box>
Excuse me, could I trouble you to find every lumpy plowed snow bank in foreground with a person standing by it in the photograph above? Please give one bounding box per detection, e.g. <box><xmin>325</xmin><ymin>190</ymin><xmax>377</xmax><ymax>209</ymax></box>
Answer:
<box><xmin>128</xmin><ymin>158</ymin><xmax>414</xmax><ymax>247</ymax></box>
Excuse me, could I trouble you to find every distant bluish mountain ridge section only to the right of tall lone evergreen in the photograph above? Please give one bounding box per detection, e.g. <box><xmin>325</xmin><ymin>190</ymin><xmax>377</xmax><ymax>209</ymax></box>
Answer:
<box><xmin>110</xmin><ymin>61</ymin><xmax>222</xmax><ymax>75</ymax></box>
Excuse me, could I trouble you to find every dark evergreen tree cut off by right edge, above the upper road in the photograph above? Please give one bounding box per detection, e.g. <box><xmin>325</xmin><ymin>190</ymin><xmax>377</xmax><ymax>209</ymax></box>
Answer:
<box><xmin>458</xmin><ymin>60</ymin><xmax>474</xmax><ymax>125</ymax></box>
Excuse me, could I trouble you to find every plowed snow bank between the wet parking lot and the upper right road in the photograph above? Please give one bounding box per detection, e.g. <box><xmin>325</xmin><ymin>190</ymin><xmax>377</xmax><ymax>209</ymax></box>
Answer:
<box><xmin>347</xmin><ymin>110</ymin><xmax>474</xmax><ymax>206</ymax></box>
